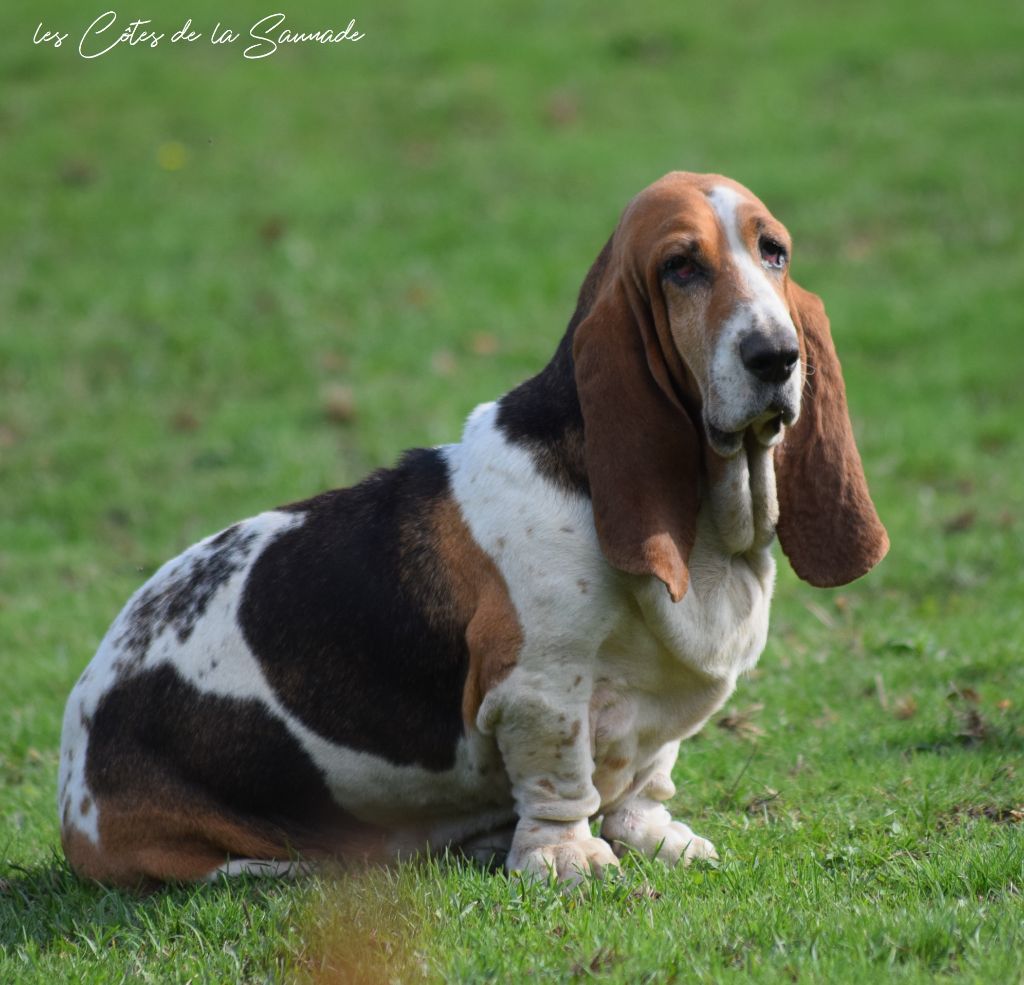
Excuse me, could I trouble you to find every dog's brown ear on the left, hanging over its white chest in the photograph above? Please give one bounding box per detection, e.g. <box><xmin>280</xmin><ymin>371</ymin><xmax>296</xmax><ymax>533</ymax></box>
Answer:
<box><xmin>571</xmin><ymin>247</ymin><xmax>700</xmax><ymax>602</ymax></box>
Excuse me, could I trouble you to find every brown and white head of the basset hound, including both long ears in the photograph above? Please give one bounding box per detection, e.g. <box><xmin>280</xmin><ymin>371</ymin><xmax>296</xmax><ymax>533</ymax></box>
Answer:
<box><xmin>571</xmin><ymin>172</ymin><xmax>888</xmax><ymax>601</ymax></box>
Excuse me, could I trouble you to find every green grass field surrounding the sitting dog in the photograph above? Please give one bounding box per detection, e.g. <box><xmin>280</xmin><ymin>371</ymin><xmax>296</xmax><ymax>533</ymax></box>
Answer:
<box><xmin>0</xmin><ymin>0</ymin><xmax>1024</xmax><ymax>983</ymax></box>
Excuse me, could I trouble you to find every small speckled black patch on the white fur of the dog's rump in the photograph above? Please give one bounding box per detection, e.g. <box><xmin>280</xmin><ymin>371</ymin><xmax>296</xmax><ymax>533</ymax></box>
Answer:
<box><xmin>115</xmin><ymin>523</ymin><xmax>257</xmax><ymax>660</ymax></box>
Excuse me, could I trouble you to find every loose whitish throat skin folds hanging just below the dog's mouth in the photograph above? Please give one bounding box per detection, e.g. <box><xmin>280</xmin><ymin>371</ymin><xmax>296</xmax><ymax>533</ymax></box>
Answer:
<box><xmin>705</xmin><ymin>433</ymin><xmax>778</xmax><ymax>554</ymax></box>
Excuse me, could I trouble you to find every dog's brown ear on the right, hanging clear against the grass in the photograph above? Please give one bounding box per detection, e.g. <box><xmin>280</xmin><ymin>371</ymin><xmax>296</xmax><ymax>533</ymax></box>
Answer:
<box><xmin>775</xmin><ymin>283</ymin><xmax>889</xmax><ymax>588</ymax></box>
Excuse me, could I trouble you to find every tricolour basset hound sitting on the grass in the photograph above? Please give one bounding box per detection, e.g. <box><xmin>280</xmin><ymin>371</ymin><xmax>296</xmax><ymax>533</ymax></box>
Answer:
<box><xmin>58</xmin><ymin>172</ymin><xmax>888</xmax><ymax>887</ymax></box>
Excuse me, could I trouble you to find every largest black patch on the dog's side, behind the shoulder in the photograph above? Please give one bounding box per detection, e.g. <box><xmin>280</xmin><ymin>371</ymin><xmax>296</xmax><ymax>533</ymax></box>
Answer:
<box><xmin>239</xmin><ymin>449</ymin><xmax>468</xmax><ymax>770</ymax></box>
